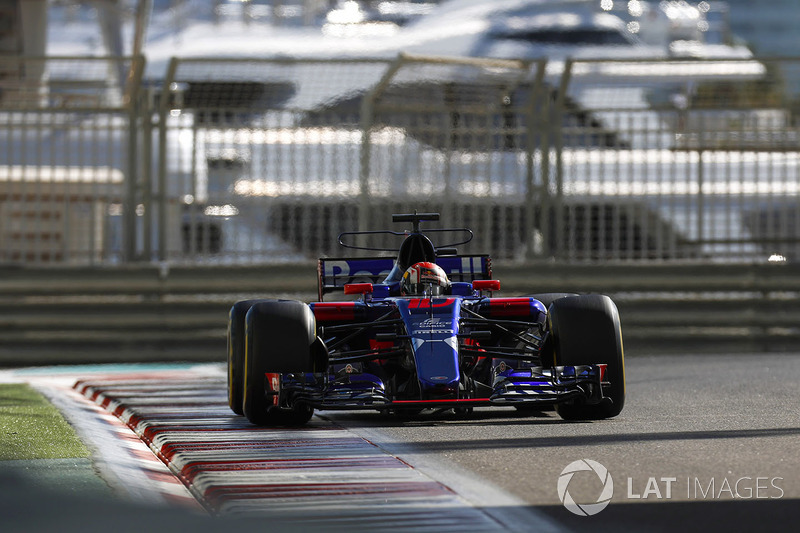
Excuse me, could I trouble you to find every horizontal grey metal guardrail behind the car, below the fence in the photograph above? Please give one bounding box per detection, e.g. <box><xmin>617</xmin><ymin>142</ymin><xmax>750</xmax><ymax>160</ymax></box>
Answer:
<box><xmin>0</xmin><ymin>262</ymin><xmax>800</xmax><ymax>365</ymax></box>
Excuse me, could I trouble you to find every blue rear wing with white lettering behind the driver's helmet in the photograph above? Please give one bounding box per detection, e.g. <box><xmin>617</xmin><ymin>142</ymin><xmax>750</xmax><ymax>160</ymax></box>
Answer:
<box><xmin>317</xmin><ymin>254</ymin><xmax>492</xmax><ymax>301</ymax></box>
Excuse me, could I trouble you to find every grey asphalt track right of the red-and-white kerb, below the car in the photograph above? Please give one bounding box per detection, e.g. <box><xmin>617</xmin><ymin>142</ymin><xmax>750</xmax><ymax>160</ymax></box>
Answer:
<box><xmin>326</xmin><ymin>354</ymin><xmax>800</xmax><ymax>532</ymax></box>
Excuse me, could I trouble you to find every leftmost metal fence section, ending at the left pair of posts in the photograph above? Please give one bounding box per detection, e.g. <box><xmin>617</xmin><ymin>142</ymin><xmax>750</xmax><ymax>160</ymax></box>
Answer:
<box><xmin>0</xmin><ymin>56</ymin><xmax>146</xmax><ymax>264</ymax></box>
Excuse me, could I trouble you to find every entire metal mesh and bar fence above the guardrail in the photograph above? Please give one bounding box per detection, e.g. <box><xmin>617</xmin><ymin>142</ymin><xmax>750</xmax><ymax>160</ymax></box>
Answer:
<box><xmin>0</xmin><ymin>55</ymin><xmax>800</xmax><ymax>265</ymax></box>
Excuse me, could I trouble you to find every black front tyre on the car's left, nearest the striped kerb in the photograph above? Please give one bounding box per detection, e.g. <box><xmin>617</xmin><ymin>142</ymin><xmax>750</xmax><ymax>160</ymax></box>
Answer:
<box><xmin>242</xmin><ymin>300</ymin><xmax>316</xmax><ymax>426</ymax></box>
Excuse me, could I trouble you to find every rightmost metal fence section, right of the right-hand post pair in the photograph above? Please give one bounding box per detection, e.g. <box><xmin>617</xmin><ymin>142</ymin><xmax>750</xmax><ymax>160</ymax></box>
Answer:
<box><xmin>554</xmin><ymin>59</ymin><xmax>800</xmax><ymax>262</ymax></box>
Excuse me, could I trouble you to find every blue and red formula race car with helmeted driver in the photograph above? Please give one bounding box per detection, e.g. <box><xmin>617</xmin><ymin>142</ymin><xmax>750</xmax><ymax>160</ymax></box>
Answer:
<box><xmin>228</xmin><ymin>212</ymin><xmax>625</xmax><ymax>425</ymax></box>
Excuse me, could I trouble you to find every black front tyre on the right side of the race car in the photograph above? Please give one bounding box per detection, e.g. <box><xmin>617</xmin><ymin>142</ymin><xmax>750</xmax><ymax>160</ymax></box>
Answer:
<box><xmin>547</xmin><ymin>294</ymin><xmax>625</xmax><ymax>420</ymax></box>
